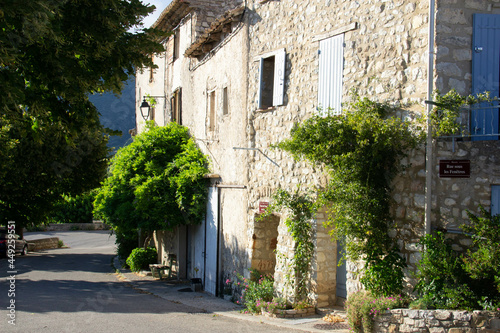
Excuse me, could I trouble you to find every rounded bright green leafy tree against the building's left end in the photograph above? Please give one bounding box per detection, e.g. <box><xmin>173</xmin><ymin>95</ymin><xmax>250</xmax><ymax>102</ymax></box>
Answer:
<box><xmin>94</xmin><ymin>123</ymin><xmax>208</xmax><ymax>252</ymax></box>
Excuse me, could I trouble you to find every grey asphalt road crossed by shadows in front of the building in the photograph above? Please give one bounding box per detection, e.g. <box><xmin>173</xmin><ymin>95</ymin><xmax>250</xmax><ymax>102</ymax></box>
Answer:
<box><xmin>0</xmin><ymin>231</ymin><xmax>300</xmax><ymax>333</ymax></box>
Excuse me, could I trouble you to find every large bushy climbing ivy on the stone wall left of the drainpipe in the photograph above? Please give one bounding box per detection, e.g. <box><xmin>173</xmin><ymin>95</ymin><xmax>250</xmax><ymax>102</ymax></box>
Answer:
<box><xmin>276</xmin><ymin>97</ymin><xmax>424</xmax><ymax>295</ymax></box>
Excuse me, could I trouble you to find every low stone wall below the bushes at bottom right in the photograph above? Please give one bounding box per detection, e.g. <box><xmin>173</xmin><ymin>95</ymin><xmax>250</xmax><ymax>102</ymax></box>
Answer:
<box><xmin>373</xmin><ymin>309</ymin><xmax>500</xmax><ymax>333</ymax></box>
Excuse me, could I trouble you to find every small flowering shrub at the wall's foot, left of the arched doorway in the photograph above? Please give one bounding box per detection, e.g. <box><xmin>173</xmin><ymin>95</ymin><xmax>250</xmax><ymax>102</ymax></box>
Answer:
<box><xmin>235</xmin><ymin>271</ymin><xmax>274</xmax><ymax>313</ymax></box>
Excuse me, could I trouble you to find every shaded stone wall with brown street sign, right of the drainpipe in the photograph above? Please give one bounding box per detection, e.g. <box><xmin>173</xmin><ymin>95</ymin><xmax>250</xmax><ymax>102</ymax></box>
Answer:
<box><xmin>432</xmin><ymin>0</ymin><xmax>500</xmax><ymax>249</ymax></box>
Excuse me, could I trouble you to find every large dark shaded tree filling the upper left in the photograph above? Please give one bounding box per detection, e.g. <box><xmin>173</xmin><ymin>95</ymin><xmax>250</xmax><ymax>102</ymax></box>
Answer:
<box><xmin>0</xmin><ymin>0</ymin><xmax>162</xmax><ymax>230</ymax></box>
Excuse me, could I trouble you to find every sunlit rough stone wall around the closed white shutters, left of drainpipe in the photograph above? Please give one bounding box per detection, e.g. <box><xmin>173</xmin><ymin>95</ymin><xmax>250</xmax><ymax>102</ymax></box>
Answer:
<box><xmin>247</xmin><ymin>0</ymin><xmax>428</xmax><ymax>302</ymax></box>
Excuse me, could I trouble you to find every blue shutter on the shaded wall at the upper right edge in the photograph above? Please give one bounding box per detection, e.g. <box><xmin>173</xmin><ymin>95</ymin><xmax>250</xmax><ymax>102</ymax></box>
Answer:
<box><xmin>470</xmin><ymin>14</ymin><xmax>500</xmax><ymax>140</ymax></box>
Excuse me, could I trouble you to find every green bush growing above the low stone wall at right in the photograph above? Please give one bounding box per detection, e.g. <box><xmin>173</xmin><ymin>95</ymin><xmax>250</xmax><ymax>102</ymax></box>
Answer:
<box><xmin>415</xmin><ymin>224</ymin><xmax>500</xmax><ymax>310</ymax></box>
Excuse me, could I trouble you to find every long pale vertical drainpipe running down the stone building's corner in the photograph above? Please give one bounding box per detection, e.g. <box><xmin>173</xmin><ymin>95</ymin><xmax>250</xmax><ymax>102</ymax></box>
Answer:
<box><xmin>425</xmin><ymin>0</ymin><xmax>436</xmax><ymax>235</ymax></box>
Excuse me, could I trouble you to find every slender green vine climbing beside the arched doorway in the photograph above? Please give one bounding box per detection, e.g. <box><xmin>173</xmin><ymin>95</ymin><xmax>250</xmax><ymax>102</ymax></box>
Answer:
<box><xmin>261</xmin><ymin>189</ymin><xmax>316</xmax><ymax>301</ymax></box>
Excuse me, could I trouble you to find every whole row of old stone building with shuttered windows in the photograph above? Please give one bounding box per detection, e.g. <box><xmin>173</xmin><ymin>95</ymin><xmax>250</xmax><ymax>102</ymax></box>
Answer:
<box><xmin>136</xmin><ymin>0</ymin><xmax>500</xmax><ymax>306</ymax></box>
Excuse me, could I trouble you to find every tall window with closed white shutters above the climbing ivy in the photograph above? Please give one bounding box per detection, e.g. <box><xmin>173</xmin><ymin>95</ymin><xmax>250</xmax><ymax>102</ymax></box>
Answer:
<box><xmin>318</xmin><ymin>34</ymin><xmax>344</xmax><ymax>116</ymax></box>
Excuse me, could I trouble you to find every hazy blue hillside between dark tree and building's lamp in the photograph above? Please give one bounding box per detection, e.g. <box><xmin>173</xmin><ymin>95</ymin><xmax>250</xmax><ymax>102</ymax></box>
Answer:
<box><xmin>90</xmin><ymin>77</ymin><xmax>135</xmax><ymax>151</ymax></box>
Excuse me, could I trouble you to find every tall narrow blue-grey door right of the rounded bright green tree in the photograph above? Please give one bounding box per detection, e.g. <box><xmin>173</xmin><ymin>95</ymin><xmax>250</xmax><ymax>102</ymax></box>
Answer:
<box><xmin>205</xmin><ymin>187</ymin><xmax>219</xmax><ymax>295</ymax></box>
